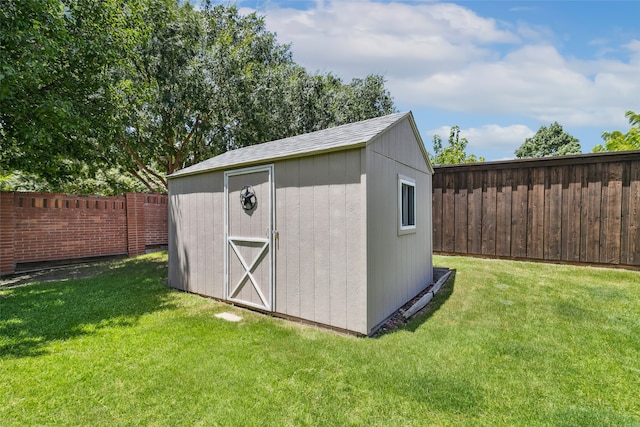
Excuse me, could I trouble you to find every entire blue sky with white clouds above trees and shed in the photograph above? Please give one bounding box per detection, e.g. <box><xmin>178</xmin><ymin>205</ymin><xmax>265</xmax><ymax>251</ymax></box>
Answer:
<box><xmin>228</xmin><ymin>0</ymin><xmax>640</xmax><ymax>160</ymax></box>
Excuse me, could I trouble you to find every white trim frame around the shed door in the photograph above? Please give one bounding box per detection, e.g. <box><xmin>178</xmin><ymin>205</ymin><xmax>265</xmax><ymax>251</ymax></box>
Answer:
<box><xmin>223</xmin><ymin>164</ymin><xmax>275</xmax><ymax>311</ymax></box>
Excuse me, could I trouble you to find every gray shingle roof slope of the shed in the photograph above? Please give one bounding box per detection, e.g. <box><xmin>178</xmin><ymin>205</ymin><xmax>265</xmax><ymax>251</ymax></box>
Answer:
<box><xmin>169</xmin><ymin>112</ymin><xmax>411</xmax><ymax>178</ymax></box>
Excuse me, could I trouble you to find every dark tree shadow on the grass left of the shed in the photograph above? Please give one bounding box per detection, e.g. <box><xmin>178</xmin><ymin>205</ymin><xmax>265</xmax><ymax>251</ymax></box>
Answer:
<box><xmin>0</xmin><ymin>255</ymin><xmax>172</xmax><ymax>358</ymax></box>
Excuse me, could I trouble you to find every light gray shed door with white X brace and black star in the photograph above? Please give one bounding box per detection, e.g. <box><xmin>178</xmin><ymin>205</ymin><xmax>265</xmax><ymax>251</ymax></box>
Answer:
<box><xmin>224</xmin><ymin>165</ymin><xmax>273</xmax><ymax>311</ymax></box>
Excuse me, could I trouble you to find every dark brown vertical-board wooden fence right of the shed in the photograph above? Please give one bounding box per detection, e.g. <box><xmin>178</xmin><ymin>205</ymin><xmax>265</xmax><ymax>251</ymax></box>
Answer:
<box><xmin>433</xmin><ymin>151</ymin><xmax>640</xmax><ymax>267</ymax></box>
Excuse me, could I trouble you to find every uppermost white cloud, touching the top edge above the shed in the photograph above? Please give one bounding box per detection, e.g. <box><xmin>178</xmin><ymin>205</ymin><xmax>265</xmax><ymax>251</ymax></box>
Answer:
<box><xmin>266</xmin><ymin>1</ymin><xmax>519</xmax><ymax>79</ymax></box>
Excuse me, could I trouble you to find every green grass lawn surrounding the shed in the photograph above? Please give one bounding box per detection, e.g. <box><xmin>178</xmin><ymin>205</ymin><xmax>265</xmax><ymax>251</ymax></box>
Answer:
<box><xmin>0</xmin><ymin>254</ymin><xmax>640</xmax><ymax>426</ymax></box>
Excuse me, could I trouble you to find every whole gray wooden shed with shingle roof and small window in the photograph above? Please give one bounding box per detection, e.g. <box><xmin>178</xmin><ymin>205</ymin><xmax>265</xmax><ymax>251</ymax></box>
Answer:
<box><xmin>169</xmin><ymin>112</ymin><xmax>433</xmax><ymax>335</ymax></box>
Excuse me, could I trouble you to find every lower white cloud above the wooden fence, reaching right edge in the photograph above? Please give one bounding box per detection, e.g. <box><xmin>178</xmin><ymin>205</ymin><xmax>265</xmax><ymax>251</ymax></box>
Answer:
<box><xmin>389</xmin><ymin>42</ymin><xmax>640</xmax><ymax>126</ymax></box>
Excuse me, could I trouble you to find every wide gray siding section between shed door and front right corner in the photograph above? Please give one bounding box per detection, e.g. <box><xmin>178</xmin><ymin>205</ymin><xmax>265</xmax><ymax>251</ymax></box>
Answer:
<box><xmin>274</xmin><ymin>149</ymin><xmax>368</xmax><ymax>333</ymax></box>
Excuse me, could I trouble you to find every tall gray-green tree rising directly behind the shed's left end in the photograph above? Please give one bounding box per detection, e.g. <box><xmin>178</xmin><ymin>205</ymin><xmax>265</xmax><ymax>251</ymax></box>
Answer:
<box><xmin>110</xmin><ymin>0</ymin><xmax>300</xmax><ymax>191</ymax></box>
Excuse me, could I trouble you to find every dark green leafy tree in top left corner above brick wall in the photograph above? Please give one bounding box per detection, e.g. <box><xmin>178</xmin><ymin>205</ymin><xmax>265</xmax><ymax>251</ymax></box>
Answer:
<box><xmin>0</xmin><ymin>0</ymin><xmax>148</xmax><ymax>183</ymax></box>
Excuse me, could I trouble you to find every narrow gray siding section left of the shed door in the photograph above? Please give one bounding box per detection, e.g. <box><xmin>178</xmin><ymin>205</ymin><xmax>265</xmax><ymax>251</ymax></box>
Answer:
<box><xmin>169</xmin><ymin>172</ymin><xmax>224</xmax><ymax>298</ymax></box>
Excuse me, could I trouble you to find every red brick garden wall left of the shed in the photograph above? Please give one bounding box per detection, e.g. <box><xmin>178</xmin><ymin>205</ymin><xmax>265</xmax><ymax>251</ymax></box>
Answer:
<box><xmin>0</xmin><ymin>192</ymin><xmax>168</xmax><ymax>274</ymax></box>
